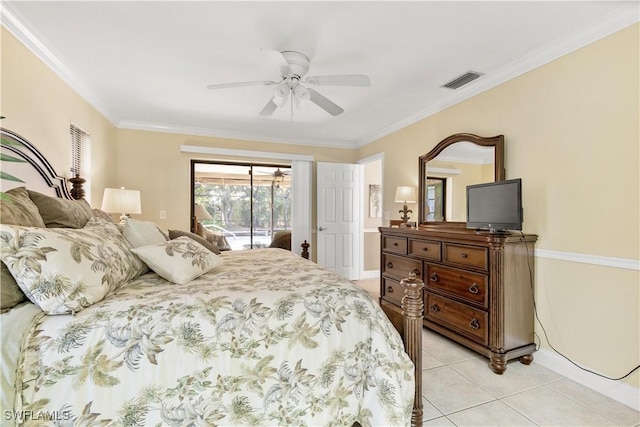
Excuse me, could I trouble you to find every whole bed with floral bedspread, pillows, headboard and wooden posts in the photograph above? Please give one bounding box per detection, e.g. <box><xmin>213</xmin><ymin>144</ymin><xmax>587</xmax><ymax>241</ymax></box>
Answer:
<box><xmin>0</xmin><ymin>129</ymin><xmax>422</xmax><ymax>426</ymax></box>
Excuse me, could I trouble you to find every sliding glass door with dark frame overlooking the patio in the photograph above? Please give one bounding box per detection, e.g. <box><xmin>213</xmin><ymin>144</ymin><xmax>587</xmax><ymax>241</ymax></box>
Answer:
<box><xmin>191</xmin><ymin>160</ymin><xmax>291</xmax><ymax>250</ymax></box>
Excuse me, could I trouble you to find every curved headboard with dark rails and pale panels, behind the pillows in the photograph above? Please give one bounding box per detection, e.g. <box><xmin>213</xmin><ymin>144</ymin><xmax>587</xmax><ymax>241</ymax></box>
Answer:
<box><xmin>0</xmin><ymin>128</ymin><xmax>73</xmax><ymax>199</ymax></box>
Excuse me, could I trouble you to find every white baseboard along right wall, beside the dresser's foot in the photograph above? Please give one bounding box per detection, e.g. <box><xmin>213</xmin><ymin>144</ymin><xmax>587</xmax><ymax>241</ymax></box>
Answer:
<box><xmin>534</xmin><ymin>348</ymin><xmax>640</xmax><ymax>411</ymax></box>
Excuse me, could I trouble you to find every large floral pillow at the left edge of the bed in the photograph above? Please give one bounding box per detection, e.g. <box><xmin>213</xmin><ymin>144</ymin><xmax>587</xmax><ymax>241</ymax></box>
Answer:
<box><xmin>0</xmin><ymin>218</ymin><xmax>147</xmax><ymax>314</ymax></box>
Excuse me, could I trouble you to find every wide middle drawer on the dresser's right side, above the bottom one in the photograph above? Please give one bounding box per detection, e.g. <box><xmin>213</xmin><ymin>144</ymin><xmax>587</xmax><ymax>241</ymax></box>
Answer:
<box><xmin>425</xmin><ymin>264</ymin><xmax>489</xmax><ymax>308</ymax></box>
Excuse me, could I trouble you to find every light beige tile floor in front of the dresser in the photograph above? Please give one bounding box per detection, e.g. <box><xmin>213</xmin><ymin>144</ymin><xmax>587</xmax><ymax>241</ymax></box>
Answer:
<box><xmin>356</xmin><ymin>279</ymin><xmax>640</xmax><ymax>426</ymax></box>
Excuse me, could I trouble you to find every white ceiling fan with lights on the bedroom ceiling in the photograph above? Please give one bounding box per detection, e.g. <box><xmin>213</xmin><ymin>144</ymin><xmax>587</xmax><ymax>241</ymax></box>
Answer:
<box><xmin>207</xmin><ymin>49</ymin><xmax>371</xmax><ymax>116</ymax></box>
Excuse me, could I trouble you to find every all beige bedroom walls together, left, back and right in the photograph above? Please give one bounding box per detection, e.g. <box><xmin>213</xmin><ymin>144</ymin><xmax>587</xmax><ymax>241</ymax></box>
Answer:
<box><xmin>0</xmin><ymin>19</ymin><xmax>640</xmax><ymax>387</ymax></box>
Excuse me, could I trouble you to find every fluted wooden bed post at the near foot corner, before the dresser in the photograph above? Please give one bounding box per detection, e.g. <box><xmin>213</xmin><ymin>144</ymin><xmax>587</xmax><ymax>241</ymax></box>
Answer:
<box><xmin>400</xmin><ymin>271</ymin><xmax>424</xmax><ymax>427</ymax></box>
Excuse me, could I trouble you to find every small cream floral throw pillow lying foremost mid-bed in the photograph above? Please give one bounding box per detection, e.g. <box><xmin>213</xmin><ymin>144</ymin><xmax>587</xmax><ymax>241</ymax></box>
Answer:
<box><xmin>131</xmin><ymin>236</ymin><xmax>223</xmax><ymax>285</ymax></box>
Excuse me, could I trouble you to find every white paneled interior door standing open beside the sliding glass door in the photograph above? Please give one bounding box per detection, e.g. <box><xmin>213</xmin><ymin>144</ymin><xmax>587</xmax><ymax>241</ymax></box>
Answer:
<box><xmin>316</xmin><ymin>162</ymin><xmax>360</xmax><ymax>280</ymax></box>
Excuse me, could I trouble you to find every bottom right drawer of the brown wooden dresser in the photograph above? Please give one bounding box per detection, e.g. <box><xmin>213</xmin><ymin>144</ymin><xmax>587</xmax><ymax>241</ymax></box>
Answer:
<box><xmin>424</xmin><ymin>292</ymin><xmax>489</xmax><ymax>345</ymax></box>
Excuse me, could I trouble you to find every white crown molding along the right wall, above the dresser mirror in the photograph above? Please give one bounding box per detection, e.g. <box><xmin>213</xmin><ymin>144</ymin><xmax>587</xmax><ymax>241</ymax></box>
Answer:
<box><xmin>355</xmin><ymin>2</ymin><xmax>640</xmax><ymax>148</ymax></box>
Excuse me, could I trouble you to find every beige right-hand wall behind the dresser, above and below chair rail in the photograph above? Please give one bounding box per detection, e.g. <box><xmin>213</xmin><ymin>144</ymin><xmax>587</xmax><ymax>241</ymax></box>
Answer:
<box><xmin>358</xmin><ymin>25</ymin><xmax>640</xmax><ymax>387</ymax></box>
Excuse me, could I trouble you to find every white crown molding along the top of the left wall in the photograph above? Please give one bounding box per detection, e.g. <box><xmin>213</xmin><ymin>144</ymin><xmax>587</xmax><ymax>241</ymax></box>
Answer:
<box><xmin>0</xmin><ymin>2</ymin><xmax>119</xmax><ymax>126</ymax></box>
